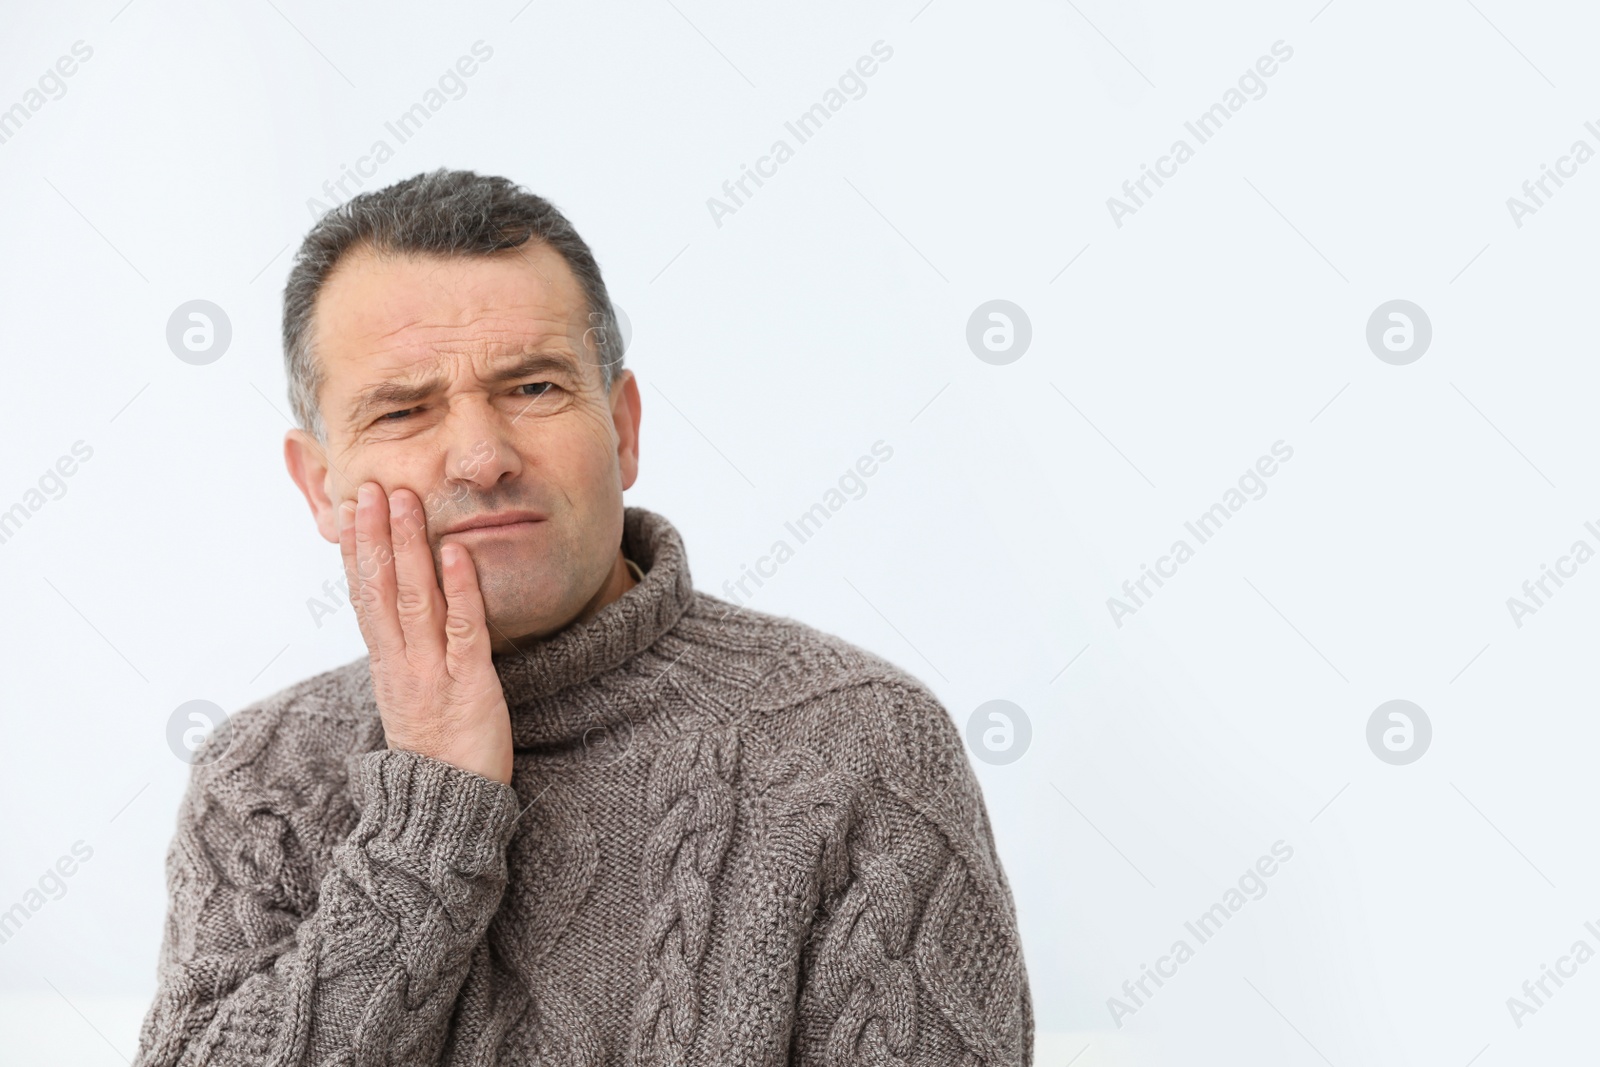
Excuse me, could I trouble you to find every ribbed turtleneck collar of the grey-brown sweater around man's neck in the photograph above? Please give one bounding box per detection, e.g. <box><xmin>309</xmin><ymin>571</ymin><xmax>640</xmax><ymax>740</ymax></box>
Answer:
<box><xmin>493</xmin><ymin>507</ymin><xmax>694</xmax><ymax>749</ymax></box>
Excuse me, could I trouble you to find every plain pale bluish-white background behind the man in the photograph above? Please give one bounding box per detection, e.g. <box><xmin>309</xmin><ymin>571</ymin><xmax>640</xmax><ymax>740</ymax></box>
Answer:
<box><xmin>0</xmin><ymin>0</ymin><xmax>1600</xmax><ymax>1067</ymax></box>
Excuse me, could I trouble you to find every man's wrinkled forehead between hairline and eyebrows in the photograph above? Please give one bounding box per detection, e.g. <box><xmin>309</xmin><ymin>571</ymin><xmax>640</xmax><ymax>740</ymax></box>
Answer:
<box><xmin>314</xmin><ymin>243</ymin><xmax>587</xmax><ymax>374</ymax></box>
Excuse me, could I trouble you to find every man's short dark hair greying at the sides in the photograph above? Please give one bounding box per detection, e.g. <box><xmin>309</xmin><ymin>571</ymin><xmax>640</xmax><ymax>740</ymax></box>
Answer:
<box><xmin>283</xmin><ymin>168</ymin><xmax>622</xmax><ymax>443</ymax></box>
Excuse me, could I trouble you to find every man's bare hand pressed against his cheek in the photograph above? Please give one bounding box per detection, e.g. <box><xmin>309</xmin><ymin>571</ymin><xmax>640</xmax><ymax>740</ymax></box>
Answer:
<box><xmin>339</xmin><ymin>482</ymin><xmax>512</xmax><ymax>784</ymax></box>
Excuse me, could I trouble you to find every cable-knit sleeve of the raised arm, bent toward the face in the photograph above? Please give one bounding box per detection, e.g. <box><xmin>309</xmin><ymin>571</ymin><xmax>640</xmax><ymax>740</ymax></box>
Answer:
<box><xmin>136</xmin><ymin>749</ymin><xmax>518</xmax><ymax>1067</ymax></box>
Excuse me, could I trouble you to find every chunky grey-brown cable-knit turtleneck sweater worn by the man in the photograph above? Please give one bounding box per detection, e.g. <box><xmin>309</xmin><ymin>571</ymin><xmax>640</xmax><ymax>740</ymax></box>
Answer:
<box><xmin>136</xmin><ymin>507</ymin><xmax>1034</xmax><ymax>1067</ymax></box>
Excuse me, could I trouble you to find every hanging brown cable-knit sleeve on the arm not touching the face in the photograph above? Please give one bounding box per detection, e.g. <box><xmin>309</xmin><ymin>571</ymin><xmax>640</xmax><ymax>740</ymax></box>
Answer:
<box><xmin>790</xmin><ymin>687</ymin><xmax>1034</xmax><ymax>1067</ymax></box>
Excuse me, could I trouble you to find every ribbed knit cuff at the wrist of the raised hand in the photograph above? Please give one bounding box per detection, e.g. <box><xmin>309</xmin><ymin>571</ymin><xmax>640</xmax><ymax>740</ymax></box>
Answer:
<box><xmin>352</xmin><ymin>749</ymin><xmax>518</xmax><ymax>877</ymax></box>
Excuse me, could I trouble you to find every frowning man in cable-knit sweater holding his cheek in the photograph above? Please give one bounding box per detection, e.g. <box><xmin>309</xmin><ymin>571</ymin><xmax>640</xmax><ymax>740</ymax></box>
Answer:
<box><xmin>138</xmin><ymin>171</ymin><xmax>1034</xmax><ymax>1067</ymax></box>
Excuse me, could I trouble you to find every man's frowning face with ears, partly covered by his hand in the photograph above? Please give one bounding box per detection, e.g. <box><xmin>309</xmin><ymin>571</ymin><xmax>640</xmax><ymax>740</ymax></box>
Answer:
<box><xmin>285</xmin><ymin>243</ymin><xmax>640</xmax><ymax>646</ymax></box>
